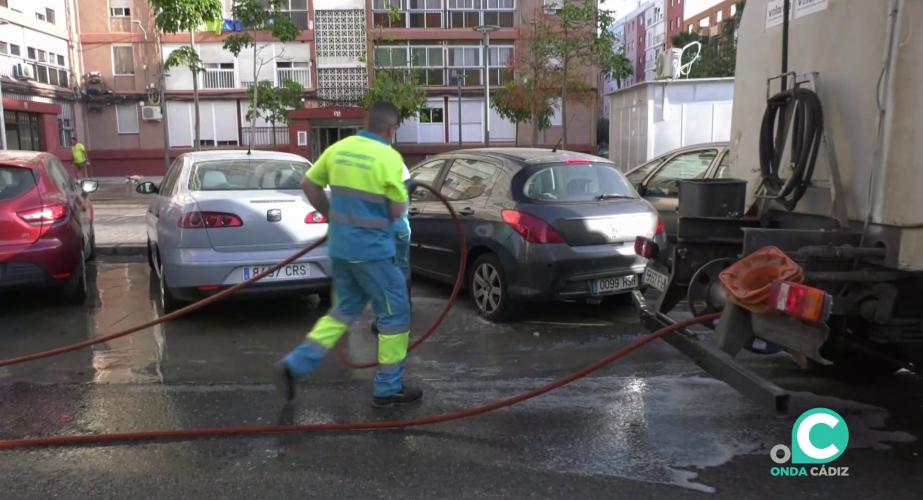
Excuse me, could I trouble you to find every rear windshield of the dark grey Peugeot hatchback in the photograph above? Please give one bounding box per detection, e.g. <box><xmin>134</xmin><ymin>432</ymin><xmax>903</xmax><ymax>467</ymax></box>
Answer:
<box><xmin>525</xmin><ymin>163</ymin><xmax>637</xmax><ymax>202</ymax></box>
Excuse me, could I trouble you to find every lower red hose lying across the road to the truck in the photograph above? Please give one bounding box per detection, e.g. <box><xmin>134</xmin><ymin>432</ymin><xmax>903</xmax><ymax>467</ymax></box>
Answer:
<box><xmin>0</xmin><ymin>314</ymin><xmax>720</xmax><ymax>449</ymax></box>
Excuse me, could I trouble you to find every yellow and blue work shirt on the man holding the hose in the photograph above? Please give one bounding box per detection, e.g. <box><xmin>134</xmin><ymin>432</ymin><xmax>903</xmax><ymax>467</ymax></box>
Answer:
<box><xmin>306</xmin><ymin>130</ymin><xmax>407</xmax><ymax>261</ymax></box>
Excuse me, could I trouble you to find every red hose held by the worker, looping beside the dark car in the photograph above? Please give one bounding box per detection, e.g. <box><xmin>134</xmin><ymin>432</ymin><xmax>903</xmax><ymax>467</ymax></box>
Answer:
<box><xmin>0</xmin><ymin>183</ymin><xmax>468</xmax><ymax>368</ymax></box>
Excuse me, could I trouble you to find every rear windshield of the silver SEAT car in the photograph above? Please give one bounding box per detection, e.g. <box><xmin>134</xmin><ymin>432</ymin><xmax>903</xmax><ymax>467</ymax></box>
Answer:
<box><xmin>189</xmin><ymin>158</ymin><xmax>310</xmax><ymax>191</ymax></box>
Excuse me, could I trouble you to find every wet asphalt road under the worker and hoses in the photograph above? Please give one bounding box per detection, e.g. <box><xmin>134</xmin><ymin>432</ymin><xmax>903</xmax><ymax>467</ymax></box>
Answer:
<box><xmin>0</xmin><ymin>258</ymin><xmax>923</xmax><ymax>499</ymax></box>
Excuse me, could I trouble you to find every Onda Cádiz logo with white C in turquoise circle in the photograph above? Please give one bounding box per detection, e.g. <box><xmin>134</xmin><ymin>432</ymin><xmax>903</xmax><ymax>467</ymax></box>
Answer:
<box><xmin>769</xmin><ymin>408</ymin><xmax>849</xmax><ymax>477</ymax></box>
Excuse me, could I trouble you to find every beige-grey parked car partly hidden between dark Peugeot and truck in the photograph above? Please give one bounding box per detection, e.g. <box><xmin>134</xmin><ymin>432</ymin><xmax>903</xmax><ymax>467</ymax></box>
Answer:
<box><xmin>625</xmin><ymin>142</ymin><xmax>730</xmax><ymax>235</ymax></box>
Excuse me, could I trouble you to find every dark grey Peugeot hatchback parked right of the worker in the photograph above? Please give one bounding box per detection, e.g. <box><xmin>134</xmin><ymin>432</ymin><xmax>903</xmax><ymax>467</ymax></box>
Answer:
<box><xmin>409</xmin><ymin>148</ymin><xmax>658</xmax><ymax>320</ymax></box>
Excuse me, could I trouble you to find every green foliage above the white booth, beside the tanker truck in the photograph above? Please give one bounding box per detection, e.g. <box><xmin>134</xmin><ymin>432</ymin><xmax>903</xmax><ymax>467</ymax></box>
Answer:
<box><xmin>672</xmin><ymin>2</ymin><xmax>744</xmax><ymax>78</ymax></box>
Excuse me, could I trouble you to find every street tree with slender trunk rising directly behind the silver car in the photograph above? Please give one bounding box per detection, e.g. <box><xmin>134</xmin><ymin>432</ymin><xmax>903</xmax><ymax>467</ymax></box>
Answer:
<box><xmin>224</xmin><ymin>0</ymin><xmax>301</xmax><ymax>148</ymax></box>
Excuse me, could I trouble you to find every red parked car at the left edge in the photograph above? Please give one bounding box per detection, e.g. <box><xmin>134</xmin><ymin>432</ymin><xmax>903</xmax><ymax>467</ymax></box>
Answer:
<box><xmin>0</xmin><ymin>151</ymin><xmax>98</xmax><ymax>303</ymax></box>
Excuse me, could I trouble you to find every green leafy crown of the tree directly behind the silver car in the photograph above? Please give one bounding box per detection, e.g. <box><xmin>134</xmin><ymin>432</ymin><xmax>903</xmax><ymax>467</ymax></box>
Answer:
<box><xmin>222</xmin><ymin>0</ymin><xmax>301</xmax><ymax>57</ymax></box>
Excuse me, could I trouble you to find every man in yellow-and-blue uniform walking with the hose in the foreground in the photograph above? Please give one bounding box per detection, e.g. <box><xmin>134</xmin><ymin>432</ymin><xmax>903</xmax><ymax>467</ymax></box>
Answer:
<box><xmin>276</xmin><ymin>103</ymin><xmax>423</xmax><ymax>408</ymax></box>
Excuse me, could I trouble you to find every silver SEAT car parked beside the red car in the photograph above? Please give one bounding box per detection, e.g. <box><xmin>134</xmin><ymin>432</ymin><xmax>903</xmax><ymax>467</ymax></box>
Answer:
<box><xmin>137</xmin><ymin>151</ymin><xmax>331</xmax><ymax>312</ymax></box>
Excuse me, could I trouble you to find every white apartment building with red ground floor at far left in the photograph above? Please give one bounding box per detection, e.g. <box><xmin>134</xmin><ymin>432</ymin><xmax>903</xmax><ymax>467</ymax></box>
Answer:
<box><xmin>0</xmin><ymin>0</ymin><xmax>77</xmax><ymax>157</ymax></box>
